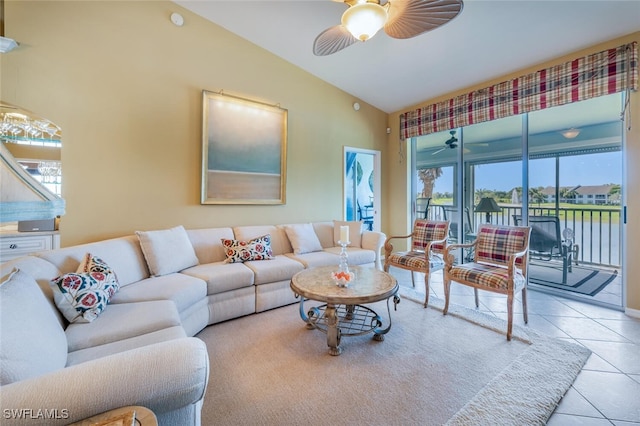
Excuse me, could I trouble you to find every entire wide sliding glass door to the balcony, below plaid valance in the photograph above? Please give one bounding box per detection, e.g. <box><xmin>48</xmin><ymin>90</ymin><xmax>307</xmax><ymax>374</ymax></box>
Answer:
<box><xmin>412</xmin><ymin>94</ymin><xmax>623</xmax><ymax>308</ymax></box>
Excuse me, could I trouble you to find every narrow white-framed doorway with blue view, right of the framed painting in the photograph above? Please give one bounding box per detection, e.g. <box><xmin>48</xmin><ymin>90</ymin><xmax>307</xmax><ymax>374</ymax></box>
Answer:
<box><xmin>343</xmin><ymin>147</ymin><xmax>381</xmax><ymax>231</ymax></box>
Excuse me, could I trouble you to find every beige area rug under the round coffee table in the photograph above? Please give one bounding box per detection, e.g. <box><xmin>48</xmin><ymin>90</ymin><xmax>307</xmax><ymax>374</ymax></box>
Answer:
<box><xmin>198</xmin><ymin>295</ymin><xmax>590</xmax><ymax>426</ymax></box>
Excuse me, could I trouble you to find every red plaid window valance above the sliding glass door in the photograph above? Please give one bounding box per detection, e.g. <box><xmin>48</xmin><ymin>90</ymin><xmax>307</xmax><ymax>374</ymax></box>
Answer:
<box><xmin>400</xmin><ymin>42</ymin><xmax>638</xmax><ymax>139</ymax></box>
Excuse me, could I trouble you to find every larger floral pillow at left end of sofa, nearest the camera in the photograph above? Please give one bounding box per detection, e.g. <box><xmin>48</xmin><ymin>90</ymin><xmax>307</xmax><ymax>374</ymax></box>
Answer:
<box><xmin>51</xmin><ymin>253</ymin><xmax>120</xmax><ymax>322</ymax></box>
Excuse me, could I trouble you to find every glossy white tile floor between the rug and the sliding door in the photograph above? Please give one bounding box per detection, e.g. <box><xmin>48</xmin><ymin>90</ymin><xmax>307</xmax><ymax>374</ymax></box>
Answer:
<box><xmin>390</xmin><ymin>268</ymin><xmax>640</xmax><ymax>426</ymax></box>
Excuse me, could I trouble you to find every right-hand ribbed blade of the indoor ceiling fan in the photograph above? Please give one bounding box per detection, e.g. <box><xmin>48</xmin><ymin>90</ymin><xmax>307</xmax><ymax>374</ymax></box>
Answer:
<box><xmin>384</xmin><ymin>0</ymin><xmax>462</xmax><ymax>38</ymax></box>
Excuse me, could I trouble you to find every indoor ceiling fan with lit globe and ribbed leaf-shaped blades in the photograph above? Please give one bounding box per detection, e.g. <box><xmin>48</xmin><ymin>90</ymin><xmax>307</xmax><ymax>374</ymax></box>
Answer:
<box><xmin>313</xmin><ymin>0</ymin><xmax>462</xmax><ymax>56</ymax></box>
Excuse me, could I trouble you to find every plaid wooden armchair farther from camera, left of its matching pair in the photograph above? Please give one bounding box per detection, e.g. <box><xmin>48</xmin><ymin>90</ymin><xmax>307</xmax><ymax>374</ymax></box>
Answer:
<box><xmin>384</xmin><ymin>219</ymin><xmax>449</xmax><ymax>308</ymax></box>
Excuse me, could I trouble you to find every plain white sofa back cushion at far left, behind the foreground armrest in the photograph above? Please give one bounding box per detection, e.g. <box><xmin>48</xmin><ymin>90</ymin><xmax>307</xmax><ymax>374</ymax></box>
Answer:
<box><xmin>0</xmin><ymin>269</ymin><xmax>67</xmax><ymax>391</ymax></box>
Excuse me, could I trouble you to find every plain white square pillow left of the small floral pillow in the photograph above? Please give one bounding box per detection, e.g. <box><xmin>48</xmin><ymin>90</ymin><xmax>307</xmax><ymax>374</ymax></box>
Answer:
<box><xmin>136</xmin><ymin>226</ymin><xmax>198</xmax><ymax>277</ymax></box>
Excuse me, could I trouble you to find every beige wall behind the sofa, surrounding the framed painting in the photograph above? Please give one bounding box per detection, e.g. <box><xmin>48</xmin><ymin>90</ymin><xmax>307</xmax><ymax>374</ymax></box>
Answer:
<box><xmin>1</xmin><ymin>1</ymin><xmax>387</xmax><ymax>246</ymax></box>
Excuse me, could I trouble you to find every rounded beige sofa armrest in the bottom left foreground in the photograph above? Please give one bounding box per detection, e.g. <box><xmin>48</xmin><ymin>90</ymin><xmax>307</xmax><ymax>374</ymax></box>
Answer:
<box><xmin>0</xmin><ymin>337</ymin><xmax>209</xmax><ymax>426</ymax></box>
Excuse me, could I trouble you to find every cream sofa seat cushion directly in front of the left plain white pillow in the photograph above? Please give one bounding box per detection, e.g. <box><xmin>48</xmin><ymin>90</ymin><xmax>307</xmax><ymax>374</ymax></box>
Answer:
<box><xmin>109</xmin><ymin>273</ymin><xmax>207</xmax><ymax>312</ymax></box>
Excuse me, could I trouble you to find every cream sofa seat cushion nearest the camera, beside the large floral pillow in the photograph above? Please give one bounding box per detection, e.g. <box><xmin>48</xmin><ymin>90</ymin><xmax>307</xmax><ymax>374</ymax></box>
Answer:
<box><xmin>65</xmin><ymin>300</ymin><xmax>181</xmax><ymax>352</ymax></box>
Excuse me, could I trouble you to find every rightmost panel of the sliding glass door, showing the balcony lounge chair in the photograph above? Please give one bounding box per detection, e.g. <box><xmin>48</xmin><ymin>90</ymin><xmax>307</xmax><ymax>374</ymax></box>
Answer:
<box><xmin>529</xmin><ymin>94</ymin><xmax>623</xmax><ymax>307</ymax></box>
